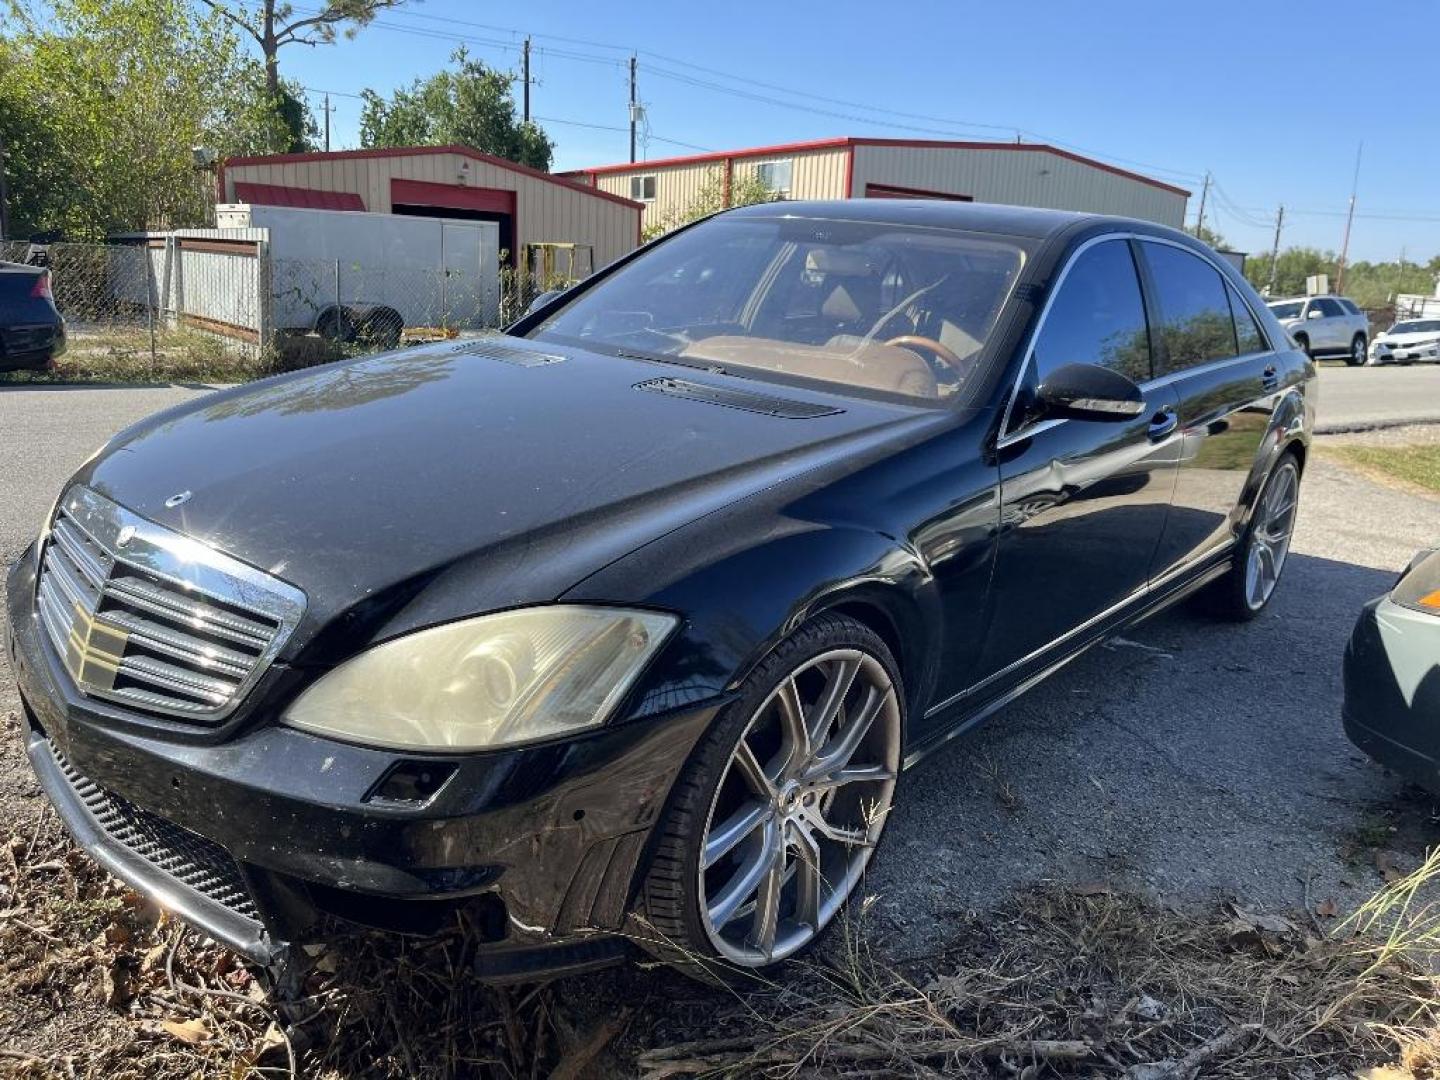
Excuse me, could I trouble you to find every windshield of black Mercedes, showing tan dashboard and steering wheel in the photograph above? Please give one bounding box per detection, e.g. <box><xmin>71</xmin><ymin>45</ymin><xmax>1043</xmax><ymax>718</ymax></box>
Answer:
<box><xmin>531</xmin><ymin>217</ymin><xmax>1024</xmax><ymax>402</ymax></box>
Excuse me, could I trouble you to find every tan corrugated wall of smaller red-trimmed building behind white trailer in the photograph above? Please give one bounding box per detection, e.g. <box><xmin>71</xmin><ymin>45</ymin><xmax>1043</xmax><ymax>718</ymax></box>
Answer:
<box><xmin>225</xmin><ymin>154</ymin><xmax>639</xmax><ymax>268</ymax></box>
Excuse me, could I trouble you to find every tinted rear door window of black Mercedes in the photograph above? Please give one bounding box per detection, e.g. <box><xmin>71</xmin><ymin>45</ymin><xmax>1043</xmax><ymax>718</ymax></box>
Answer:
<box><xmin>1142</xmin><ymin>240</ymin><xmax>1238</xmax><ymax>374</ymax></box>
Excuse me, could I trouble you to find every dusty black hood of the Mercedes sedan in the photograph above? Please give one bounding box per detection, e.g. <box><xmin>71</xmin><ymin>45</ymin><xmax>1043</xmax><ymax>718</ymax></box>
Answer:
<box><xmin>78</xmin><ymin>338</ymin><xmax>953</xmax><ymax>661</ymax></box>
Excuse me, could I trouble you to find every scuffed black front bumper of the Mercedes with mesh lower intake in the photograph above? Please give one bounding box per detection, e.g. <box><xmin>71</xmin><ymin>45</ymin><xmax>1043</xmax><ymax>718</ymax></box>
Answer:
<box><xmin>6</xmin><ymin>557</ymin><xmax>720</xmax><ymax>978</ymax></box>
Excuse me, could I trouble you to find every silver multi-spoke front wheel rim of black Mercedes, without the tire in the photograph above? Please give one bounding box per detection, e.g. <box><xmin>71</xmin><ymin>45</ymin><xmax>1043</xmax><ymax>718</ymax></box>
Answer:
<box><xmin>698</xmin><ymin>648</ymin><xmax>900</xmax><ymax>968</ymax></box>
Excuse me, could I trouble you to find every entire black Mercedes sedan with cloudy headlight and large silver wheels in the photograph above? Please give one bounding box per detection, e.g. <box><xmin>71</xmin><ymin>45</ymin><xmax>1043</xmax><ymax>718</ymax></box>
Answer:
<box><xmin>7</xmin><ymin>200</ymin><xmax>1313</xmax><ymax>978</ymax></box>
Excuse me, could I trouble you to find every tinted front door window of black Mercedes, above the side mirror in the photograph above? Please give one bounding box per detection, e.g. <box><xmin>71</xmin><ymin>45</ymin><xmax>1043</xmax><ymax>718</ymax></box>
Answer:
<box><xmin>1032</xmin><ymin>240</ymin><xmax>1151</xmax><ymax>386</ymax></box>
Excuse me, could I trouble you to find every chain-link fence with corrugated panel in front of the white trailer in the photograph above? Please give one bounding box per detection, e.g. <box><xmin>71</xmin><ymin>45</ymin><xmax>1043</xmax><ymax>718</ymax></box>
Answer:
<box><xmin>0</xmin><ymin>240</ymin><xmax>573</xmax><ymax>379</ymax></box>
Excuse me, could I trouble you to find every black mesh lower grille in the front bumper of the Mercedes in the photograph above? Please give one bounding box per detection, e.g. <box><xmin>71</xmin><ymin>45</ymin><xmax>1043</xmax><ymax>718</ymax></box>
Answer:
<box><xmin>48</xmin><ymin>742</ymin><xmax>261</xmax><ymax>922</ymax></box>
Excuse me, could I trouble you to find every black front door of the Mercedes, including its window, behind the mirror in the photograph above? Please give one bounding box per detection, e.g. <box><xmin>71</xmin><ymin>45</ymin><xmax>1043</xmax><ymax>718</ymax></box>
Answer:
<box><xmin>978</xmin><ymin>238</ymin><xmax>1179</xmax><ymax>688</ymax></box>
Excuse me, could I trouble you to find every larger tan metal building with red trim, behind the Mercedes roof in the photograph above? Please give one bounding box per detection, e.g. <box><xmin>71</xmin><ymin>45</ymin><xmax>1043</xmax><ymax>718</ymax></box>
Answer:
<box><xmin>566</xmin><ymin>138</ymin><xmax>1189</xmax><ymax>228</ymax></box>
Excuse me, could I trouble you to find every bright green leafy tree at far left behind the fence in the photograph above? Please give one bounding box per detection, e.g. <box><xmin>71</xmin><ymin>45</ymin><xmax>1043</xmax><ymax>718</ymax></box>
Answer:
<box><xmin>3</xmin><ymin>0</ymin><xmax>298</xmax><ymax>239</ymax></box>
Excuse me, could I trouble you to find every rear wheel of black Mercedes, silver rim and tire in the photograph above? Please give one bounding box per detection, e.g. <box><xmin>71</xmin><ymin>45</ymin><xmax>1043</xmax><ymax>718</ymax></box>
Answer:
<box><xmin>1198</xmin><ymin>451</ymin><xmax>1300</xmax><ymax>622</ymax></box>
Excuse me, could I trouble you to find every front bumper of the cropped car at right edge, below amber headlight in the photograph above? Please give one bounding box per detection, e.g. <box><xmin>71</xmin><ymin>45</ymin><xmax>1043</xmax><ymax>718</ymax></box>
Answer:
<box><xmin>1342</xmin><ymin>596</ymin><xmax>1440</xmax><ymax>795</ymax></box>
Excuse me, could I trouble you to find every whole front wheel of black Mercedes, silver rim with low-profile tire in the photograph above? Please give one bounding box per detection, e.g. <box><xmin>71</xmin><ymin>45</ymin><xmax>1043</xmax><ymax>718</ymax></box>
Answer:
<box><xmin>634</xmin><ymin>613</ymin><xmax>904</xmax><ymax>984</ymax></box>
